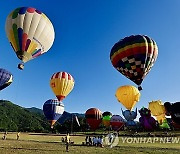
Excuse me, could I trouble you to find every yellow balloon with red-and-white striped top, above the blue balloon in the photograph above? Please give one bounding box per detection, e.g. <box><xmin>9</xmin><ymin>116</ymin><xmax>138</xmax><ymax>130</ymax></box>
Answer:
<box><xmin>50</xmin><ymin>72</ymin><xmax>74</xmax><ymax>101</ymax></box>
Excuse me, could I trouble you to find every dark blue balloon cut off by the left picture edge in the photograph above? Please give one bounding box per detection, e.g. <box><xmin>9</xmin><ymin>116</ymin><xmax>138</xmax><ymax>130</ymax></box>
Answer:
<box><xmin>0</xmin><ymin>68</ymin><xmax>13</xmax><ymax>90</ymax></box>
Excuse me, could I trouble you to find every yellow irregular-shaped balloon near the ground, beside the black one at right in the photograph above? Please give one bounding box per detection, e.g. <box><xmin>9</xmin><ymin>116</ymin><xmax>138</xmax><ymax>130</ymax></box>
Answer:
<box><xmin>149</xmin><ymin>100</ymin><xmax>166</xmax><ymax>124</ymax></box>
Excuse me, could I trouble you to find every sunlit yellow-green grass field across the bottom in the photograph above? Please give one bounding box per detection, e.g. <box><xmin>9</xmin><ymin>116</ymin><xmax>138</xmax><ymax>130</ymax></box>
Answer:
<box><xmin>0</xmin><ymin>133</ymin><xmax>180</xmax><ymax>154</ymax></box>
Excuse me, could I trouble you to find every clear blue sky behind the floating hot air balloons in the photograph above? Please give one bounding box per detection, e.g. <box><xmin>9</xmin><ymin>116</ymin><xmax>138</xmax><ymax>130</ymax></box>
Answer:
<box><xmin>0</xmin><ymin>0</ymin><xmax>180</xmax><ymax>118</ymax></box>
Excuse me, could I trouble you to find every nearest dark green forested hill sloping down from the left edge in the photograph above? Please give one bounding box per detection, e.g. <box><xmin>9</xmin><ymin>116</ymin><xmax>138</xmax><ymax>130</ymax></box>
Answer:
<box><xmin>0</xmin><ymin>100</ymin><xmax>49</xmax><ymax>132</ymax></box>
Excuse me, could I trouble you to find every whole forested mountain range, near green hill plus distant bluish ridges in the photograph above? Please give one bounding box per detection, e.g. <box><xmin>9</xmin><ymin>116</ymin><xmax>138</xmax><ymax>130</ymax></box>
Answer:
<box><xmin>0</xmin><ymin>100</ymin><xmax>84</xmax><ymax>132</ymax></box>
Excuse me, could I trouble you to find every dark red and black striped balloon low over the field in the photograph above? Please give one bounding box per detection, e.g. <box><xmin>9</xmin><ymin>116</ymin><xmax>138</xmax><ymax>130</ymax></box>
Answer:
<box><xmin>85</xmin><ymin>108</ymin><xmax>102</xmax><ymax>131</ymax></box>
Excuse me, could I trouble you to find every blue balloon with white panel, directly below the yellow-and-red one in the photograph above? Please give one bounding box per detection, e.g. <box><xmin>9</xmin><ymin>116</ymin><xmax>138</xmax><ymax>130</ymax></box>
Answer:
<box><xmin>43</xmin><ymin>99</ymin><xmax>64</xmax><ymax>128</ymax></box>
